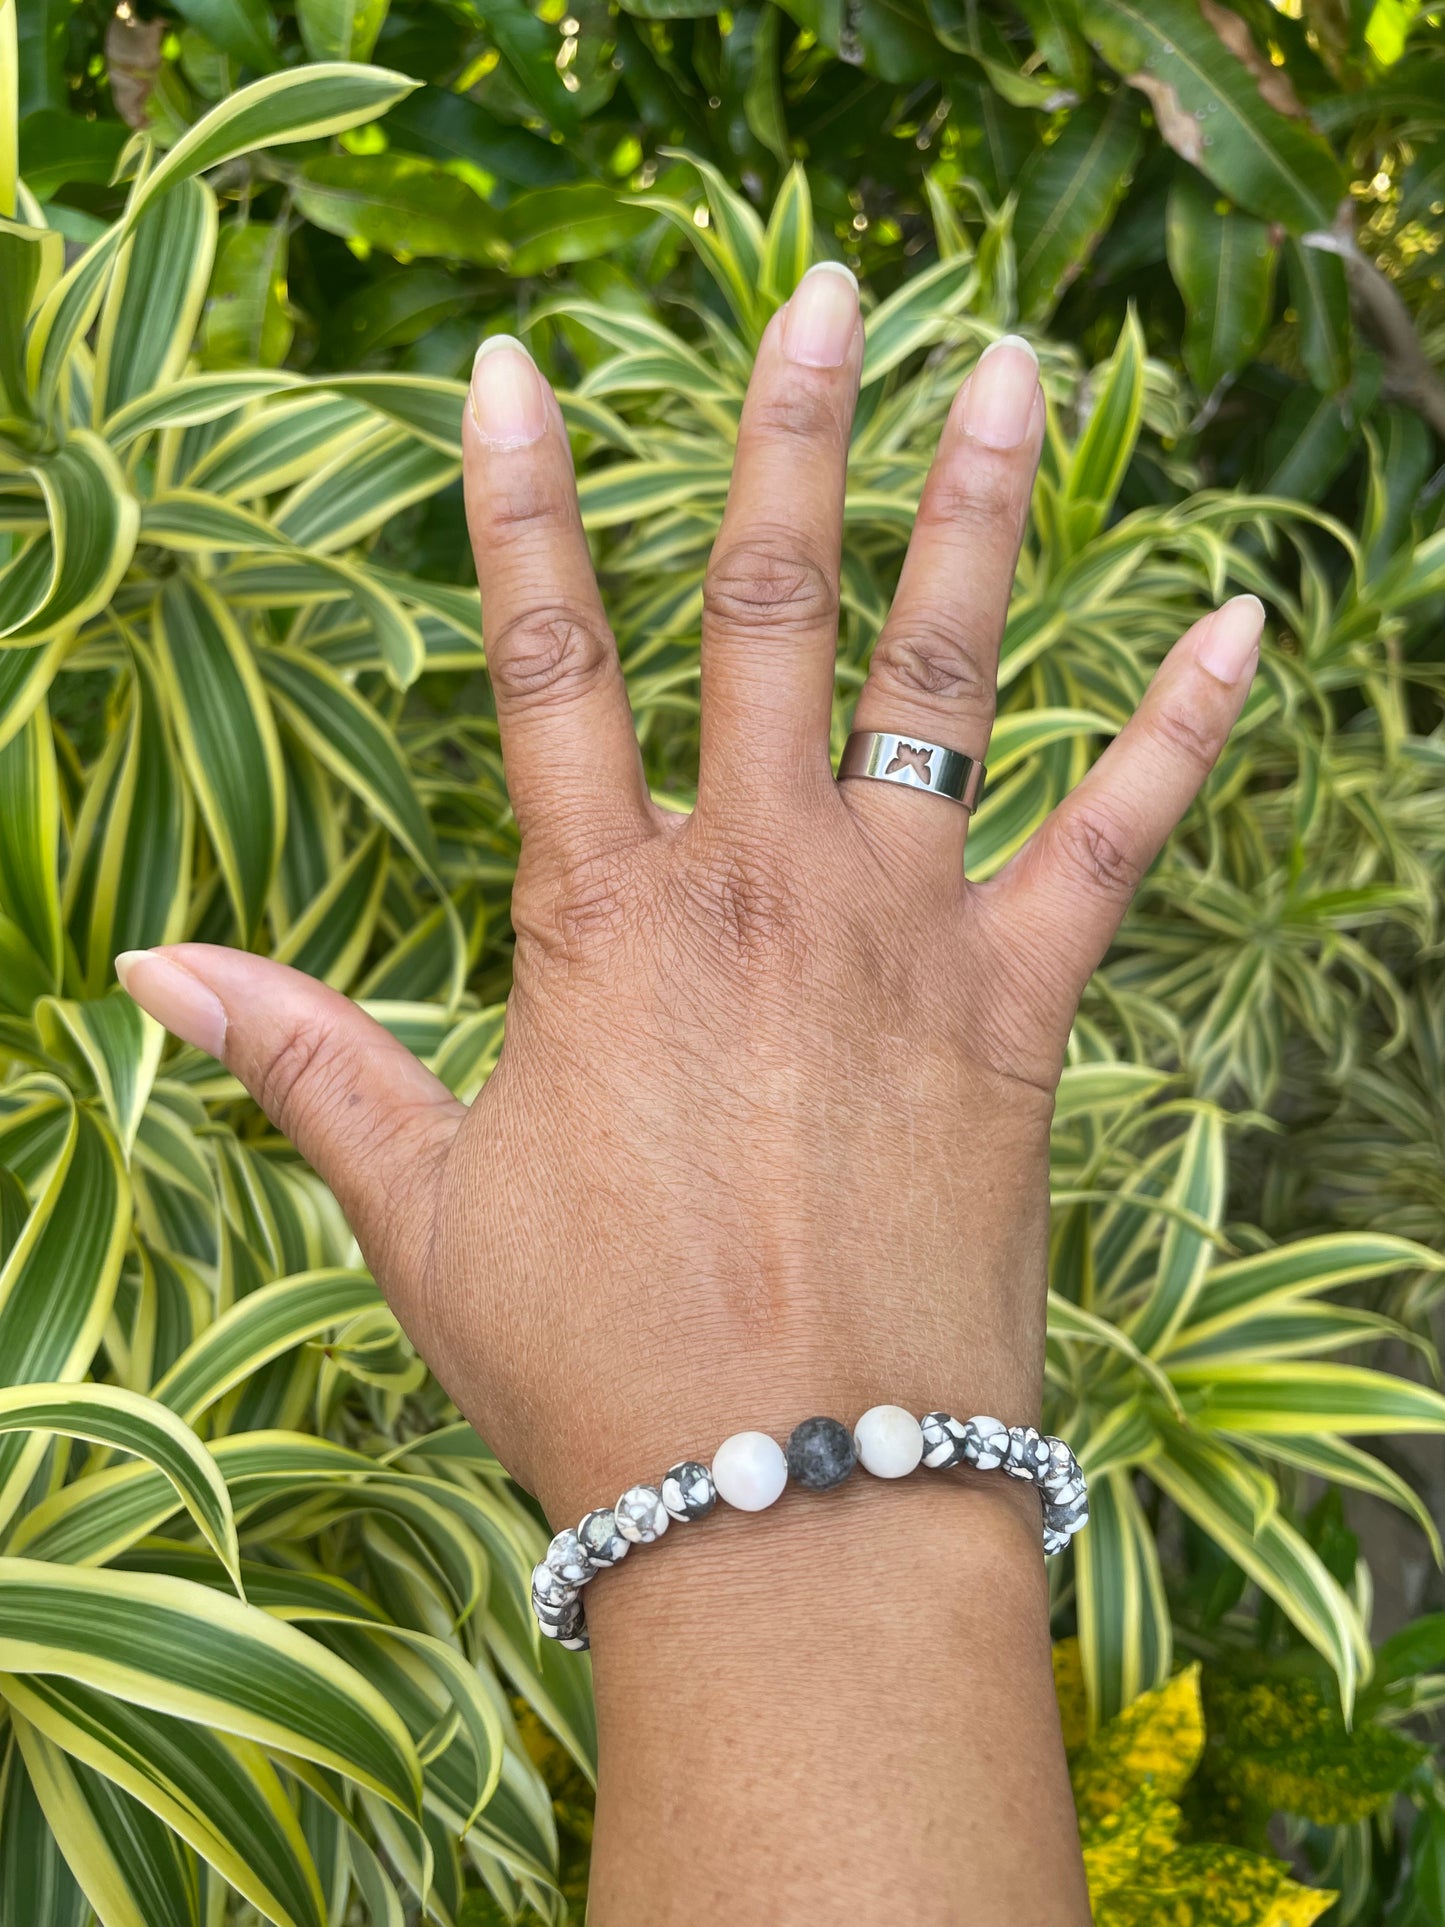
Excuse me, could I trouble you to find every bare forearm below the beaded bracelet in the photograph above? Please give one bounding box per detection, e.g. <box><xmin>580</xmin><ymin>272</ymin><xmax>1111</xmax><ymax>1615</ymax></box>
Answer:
<box><xmin>588</xmin><ymin>1476</ymin><xmax>1089</xmax><ymax>1927</ymax></box>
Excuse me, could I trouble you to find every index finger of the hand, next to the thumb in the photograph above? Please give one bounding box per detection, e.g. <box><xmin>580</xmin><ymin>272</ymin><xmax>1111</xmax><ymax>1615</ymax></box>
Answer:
<box><xmin>462</xmin><ymin>335</ymin><xmax>653</xmax><ymax>858</ymax></box>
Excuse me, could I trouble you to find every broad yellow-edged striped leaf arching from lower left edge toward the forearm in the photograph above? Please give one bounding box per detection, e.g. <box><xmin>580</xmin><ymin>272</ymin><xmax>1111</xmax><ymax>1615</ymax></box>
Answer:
<box><xmin>0</xmin><ymin>1559</ymin><xmax>420</xmax><ymax>1813</ymax></box>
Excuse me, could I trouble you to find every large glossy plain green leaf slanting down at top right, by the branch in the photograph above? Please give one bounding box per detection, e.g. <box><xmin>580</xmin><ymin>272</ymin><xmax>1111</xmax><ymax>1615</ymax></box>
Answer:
<box><xmin>1081</xmin><ymin>0</ymin><xmax>1345</xmax><ymax>233</ymax></box>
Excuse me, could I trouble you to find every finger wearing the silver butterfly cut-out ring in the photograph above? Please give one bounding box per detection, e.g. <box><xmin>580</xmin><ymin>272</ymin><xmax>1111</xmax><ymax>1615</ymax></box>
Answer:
<box><xmin>844</xmin><ymin>335</ymin><xmax>1044</xmax><ymax>873</ymax></box>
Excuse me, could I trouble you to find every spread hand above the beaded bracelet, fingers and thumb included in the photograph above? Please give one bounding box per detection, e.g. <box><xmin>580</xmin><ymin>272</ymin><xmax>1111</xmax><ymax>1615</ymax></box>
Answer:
<box><xmin>123</xmin><ymin>268</ymin><xmax>1262</xmax><ymax>1927</ymax></box>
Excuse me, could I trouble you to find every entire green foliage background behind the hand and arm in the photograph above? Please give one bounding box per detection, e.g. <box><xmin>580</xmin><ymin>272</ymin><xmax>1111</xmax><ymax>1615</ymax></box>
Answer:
<box><xmin>0</xmin><ymin>0</ymin><xmax>1445</xmax><ymax>1927</ymax></box>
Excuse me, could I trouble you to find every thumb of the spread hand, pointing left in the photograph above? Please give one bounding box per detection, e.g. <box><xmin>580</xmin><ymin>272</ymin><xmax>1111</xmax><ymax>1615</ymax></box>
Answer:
<box><xmin>116</xmin><ymin>944</ymin><xmax>464</xmax><ymax>1281</ymax></box>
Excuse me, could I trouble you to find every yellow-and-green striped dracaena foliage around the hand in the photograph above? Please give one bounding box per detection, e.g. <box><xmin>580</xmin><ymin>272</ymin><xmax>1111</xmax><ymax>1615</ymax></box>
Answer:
<box><xmin>0</xmin><ymin>67</ymin><xmax>1441</xmax><ymax>1927</ymax></box>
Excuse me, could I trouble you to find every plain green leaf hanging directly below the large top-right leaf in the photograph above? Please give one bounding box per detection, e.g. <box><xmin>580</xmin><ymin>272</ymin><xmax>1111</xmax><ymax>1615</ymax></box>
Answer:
<box><xmin>1166</xmin><ymin>173</ymin><xmax>1275</xmax><ymax>395</ymax></box>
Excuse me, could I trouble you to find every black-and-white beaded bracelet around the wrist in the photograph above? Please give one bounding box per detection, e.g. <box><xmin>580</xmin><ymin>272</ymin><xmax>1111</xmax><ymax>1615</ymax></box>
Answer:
<box><xmin>532</xmin><ymin>1405</ymin><xmax>1089</xmax><ymax>1653</ymax></box>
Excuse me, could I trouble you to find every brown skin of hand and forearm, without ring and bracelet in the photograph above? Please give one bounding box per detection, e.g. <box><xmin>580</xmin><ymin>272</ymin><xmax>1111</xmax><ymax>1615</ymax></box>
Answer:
<box><xmin>125</xmin><ymin>275</ymin><xmax>1258</xmax><ymax>1927</ymax></box>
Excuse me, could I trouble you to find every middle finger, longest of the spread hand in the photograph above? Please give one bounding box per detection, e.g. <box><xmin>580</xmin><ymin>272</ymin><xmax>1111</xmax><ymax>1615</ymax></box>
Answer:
<box><xmin>697</xmin><ymin>262</ymin><xmax>863</xmax><ymax>809</ymax></box>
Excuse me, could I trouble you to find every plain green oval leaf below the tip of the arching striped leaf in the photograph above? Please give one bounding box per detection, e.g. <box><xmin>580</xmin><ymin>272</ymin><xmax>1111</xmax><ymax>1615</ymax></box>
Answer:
<box><xmin>293</xmin><ymin>152</ymin><xmax>508</xmax><ymax>264</ymax></box>
